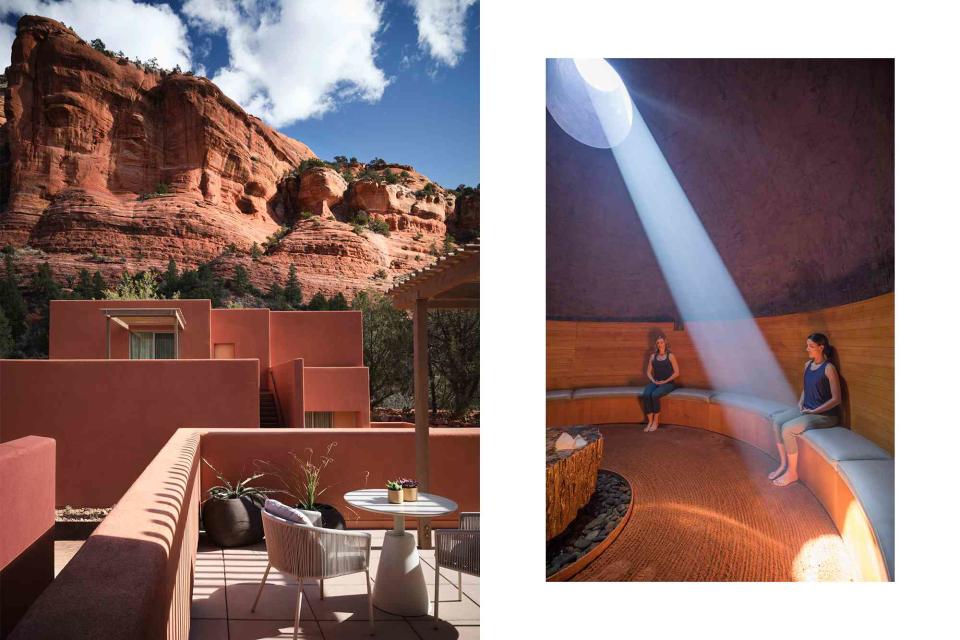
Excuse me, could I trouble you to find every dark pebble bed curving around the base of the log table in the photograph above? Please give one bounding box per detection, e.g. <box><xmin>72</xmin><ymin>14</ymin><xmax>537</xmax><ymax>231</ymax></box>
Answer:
<box><xmin>547</xmin><ymin>470</ymin><xmax>630</xmax><ymax>578</ymax></box>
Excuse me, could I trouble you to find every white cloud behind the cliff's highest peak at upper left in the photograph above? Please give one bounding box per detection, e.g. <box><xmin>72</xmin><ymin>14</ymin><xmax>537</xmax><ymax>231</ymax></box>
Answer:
<box><xmin>0</xmin><ymin>0</ymin><xmax>191</xmax><ymax>69</ymax></box>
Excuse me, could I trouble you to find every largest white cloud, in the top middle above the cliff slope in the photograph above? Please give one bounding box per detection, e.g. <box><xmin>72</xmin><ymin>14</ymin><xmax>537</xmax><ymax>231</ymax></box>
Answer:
<box><xmin>183</xmin><ymin>0</ymin><xmax>389</xmax><ymax>127</ymax></box>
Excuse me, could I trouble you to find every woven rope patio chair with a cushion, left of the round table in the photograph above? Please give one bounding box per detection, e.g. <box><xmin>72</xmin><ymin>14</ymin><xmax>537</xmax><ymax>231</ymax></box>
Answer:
<box><xmin>250</xmin><ymin>511</ymin><xmax>373</xmax><ymax>640</ymax></box>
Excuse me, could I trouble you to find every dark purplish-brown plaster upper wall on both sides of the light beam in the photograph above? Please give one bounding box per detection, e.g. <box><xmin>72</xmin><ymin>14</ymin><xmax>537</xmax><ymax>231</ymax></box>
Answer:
<box><xmin>546</xmin><ymin>60</ymin><xmax>894</xmax><ymax>321</ymax></box>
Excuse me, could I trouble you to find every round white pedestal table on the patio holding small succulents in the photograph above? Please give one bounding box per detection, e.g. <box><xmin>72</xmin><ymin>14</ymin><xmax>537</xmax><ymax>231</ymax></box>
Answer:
<box><xmin>343</xmin><ymin>489</ymin><xmax>457</xmax><ymax>616</ymax></box>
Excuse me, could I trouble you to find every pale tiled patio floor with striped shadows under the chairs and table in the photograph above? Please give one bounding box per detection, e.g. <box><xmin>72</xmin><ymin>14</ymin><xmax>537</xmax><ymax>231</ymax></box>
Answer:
<box><xmin>190</xmin><ymin>530</ymin><xmax>480</xmax><ymax>640</ymax></box>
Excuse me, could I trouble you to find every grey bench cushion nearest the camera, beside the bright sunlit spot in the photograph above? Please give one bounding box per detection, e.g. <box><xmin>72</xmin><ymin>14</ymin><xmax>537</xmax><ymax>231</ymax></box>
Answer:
<box><xmin>838</xmin><ymin>460</ymin><xmax>894</xmax><ymax>580</ymax></box>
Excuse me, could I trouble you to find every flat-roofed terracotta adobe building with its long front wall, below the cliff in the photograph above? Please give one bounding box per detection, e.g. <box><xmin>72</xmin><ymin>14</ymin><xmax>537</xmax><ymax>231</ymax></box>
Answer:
<box><xmin>0</xmin><ymin>300</ymin><xmax>374</xmax><ymax>506</ymax></box>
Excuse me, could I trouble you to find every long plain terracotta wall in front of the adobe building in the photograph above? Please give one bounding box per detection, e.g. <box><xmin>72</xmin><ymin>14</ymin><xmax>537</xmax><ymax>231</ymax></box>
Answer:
<box><xmin>0</xmin><ymin>360</ymin><xmax>260</xmax><ymax>506</ymax></box>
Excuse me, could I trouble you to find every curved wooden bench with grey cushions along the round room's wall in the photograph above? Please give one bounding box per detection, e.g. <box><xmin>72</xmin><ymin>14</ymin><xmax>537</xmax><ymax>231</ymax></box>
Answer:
<box><xmin>547</xmin><ymin>386</ymin><xmax>894</xmax><ymax>581</ymax></box>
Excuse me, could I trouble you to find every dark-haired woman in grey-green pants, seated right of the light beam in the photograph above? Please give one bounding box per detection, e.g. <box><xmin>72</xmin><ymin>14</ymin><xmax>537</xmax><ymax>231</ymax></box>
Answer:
<box><xmin>767</xmin><ymin>333</ymin><xmax>841</xmax><ymax>487</ymax></box>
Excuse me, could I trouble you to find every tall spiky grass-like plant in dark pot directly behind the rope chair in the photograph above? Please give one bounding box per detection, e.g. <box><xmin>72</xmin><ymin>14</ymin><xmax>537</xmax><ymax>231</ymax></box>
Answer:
<box><xmin>260</xmin><ymin>442</ymin><xmax>347</xmax><ymax>529</ymax></box>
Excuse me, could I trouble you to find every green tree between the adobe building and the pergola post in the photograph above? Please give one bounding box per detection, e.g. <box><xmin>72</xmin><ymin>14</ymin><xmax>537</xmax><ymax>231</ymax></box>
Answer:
<box><xmin>350</xmin><ymin>291</ymin><xmax>413</xmax><ymax>407</ymax></box>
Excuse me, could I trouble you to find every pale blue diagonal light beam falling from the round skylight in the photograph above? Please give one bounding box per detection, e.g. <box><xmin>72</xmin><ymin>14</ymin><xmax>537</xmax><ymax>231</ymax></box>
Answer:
<box><xmin>548</xmin><ymin>57</ymin><xmax>799</xmax><ymax>405</ymax></box>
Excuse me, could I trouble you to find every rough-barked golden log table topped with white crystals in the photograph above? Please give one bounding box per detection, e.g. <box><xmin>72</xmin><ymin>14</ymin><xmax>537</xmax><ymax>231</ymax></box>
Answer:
<box><xmin>547</xmin><ymin>427</ymin><xmax>603</xmax><ymax>540</ymax></box>
